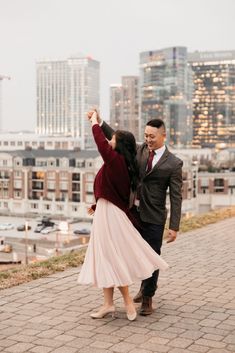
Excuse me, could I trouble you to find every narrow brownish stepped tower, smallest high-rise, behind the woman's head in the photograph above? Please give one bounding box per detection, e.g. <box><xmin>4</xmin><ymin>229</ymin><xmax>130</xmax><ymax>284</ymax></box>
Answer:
<box><xmin>110</xmin><ymin>76</ymin><xmax>139</xmax><ymax>139</ymax></box>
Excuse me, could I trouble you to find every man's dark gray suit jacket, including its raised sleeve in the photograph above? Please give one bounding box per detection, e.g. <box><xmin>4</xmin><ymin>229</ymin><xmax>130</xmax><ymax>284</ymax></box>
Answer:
<box><xmin>101</xmin><ymin>122</ymin><xmax>183</xmax><ymax>231</ymax></box>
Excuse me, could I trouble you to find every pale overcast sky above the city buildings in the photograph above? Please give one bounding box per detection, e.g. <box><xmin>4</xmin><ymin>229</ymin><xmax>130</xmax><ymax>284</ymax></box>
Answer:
<box><xmin>0</xmin><ymin>0</ymin><xmax>235</xmax><ymax>131</ymax></box>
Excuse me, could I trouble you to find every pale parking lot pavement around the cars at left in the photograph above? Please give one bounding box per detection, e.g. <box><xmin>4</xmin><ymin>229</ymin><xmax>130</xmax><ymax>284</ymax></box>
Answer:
<box><xmin>0</xmin><ymin>212</ymin><xmax>91</xmax><ymax>268</ymax></box>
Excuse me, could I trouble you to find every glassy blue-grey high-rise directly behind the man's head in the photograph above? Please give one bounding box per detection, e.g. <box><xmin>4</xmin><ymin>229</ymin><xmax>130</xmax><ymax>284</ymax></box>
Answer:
<box><xmin>140</xmin><ymin>47</ymin><xmax>193</xmax><ymax>147</ymax></box>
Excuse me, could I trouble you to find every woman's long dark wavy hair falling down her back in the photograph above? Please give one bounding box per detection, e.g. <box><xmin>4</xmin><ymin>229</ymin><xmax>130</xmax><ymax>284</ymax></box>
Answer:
<box><xmin>115</xmin><ymin>130</ymin><xmax>139</xmax><ymax>191</ymax></box>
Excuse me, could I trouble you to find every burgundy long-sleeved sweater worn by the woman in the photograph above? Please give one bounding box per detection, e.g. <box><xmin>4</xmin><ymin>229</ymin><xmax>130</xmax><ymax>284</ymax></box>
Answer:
<box><xmin>92</xmin><ymin>124</ymin><xmax>130</xmax><ymax>214</ymax></box>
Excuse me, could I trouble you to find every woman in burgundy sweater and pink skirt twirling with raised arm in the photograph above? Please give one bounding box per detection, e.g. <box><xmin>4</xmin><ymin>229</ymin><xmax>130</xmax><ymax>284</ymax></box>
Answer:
<box><xmin>78</xmin><ymin>111</ymin><xmax>168</xmax><ymax>321</ymax></box>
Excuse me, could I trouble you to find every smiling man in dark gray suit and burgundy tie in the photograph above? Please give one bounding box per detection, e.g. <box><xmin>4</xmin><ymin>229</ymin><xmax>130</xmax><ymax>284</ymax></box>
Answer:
<box><xmin>88</xmin><ymin>109</ymin><xmax>183</xmax><ymax>316</ymax></box>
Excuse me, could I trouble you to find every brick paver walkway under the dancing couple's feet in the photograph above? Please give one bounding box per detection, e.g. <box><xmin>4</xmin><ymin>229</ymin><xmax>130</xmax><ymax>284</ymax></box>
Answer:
<box><xmin>0</xmin><ymin>218</ymin><xmax>235</xmax><ymax>353</ymax></box>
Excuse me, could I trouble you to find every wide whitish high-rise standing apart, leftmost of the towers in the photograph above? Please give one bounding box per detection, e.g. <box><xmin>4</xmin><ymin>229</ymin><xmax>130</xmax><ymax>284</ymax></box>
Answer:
<box><xmin>37</xmin><ymin>56</ymin><xmax>100</xmax><ymax>149</ymax></box>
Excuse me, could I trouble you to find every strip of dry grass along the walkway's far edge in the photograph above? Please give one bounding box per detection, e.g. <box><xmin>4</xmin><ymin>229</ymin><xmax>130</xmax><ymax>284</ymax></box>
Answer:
<box><xmin>0</xmin><ymin>207</ymin><xmax>235</xmax><ymax>290</ymax></box>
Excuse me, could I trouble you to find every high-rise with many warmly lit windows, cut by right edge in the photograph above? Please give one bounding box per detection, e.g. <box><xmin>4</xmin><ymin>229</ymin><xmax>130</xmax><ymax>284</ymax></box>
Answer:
<box><xmin>188</xmin><ymin>50</ymin><xmax>235</xmax><ymax>148</ymax></box>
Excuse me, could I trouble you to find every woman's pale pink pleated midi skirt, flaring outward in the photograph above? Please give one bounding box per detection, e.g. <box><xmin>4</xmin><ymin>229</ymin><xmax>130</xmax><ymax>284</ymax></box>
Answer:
<box><xmin>78</xmin><ymin>199</ymin><xmax>169</xmax><ymax>288</ymax></box>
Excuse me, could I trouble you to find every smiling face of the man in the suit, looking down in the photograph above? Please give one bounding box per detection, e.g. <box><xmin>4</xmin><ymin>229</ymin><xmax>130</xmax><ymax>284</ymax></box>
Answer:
<box><xmin>144</xmin><ymin>125</ymin><xmax>166</xmax><ymax>150</ymax></box>
